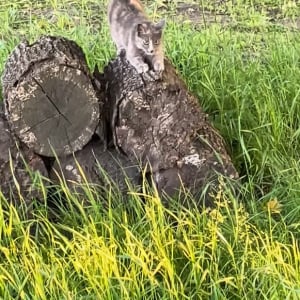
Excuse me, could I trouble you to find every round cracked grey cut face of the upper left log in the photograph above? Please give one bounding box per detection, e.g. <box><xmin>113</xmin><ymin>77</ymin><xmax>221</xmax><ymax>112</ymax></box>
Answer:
<box><xmin>7</xmin><ymin>62</ymin><xmax>99</xmax><ymax>156</ymax></box>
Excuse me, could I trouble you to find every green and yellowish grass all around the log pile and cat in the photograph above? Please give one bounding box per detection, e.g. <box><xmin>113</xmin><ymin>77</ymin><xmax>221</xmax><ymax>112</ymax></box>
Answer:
<box><xmin>0</xmin><ymin>0</ymin><xmax>300</xmax><ymax>299</ymax></box>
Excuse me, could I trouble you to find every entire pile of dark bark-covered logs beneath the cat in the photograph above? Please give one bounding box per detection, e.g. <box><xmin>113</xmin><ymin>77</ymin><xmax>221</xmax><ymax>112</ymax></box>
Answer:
<box><xmin>0</xmin><ymin>36</ymin><xmax>238</xmax><ymax>211</ymax></box>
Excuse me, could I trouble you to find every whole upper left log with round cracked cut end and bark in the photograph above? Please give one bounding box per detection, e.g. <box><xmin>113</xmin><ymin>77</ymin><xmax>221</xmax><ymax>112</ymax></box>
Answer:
<box><xmin>2</xmin><ymin>36</ymin><xmax>99</xmax><ymax>156</ymax></box>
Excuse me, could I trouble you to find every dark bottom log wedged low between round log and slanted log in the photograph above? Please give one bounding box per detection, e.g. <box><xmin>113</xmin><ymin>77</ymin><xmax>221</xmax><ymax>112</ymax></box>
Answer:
<box><xmin>50</xmin><ymin>140</ymin><xmax>141</xmax><ymax>199</ymax></box>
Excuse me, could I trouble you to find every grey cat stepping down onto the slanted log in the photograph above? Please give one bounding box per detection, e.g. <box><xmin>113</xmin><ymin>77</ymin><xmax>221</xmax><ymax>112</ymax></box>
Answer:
<box><xmin>108</xmin><ymin>0</ymin><xmax>165</xmax><ymax>73</ymax></box>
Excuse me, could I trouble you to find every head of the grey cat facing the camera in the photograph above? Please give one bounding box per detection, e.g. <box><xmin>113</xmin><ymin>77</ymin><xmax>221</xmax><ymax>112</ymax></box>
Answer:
<box><xmin>135</xmin><ymin>20</ymin><xmax>165</xmax><ymax>55</ymax></box>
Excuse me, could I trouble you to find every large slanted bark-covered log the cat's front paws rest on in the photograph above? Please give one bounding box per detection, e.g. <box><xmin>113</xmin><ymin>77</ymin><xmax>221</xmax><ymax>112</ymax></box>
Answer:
<box><xmin>104</xmin><ymin>54</ymin><xmax>238</xmax><ymax>206</ymax></box>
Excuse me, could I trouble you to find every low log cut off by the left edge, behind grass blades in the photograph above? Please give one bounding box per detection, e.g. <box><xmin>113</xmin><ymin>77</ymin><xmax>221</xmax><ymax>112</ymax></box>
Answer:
<box><xmin>0</xmin><ymin>105</ymin><xmax>48</xmax><ymax>206</ymax></box>
